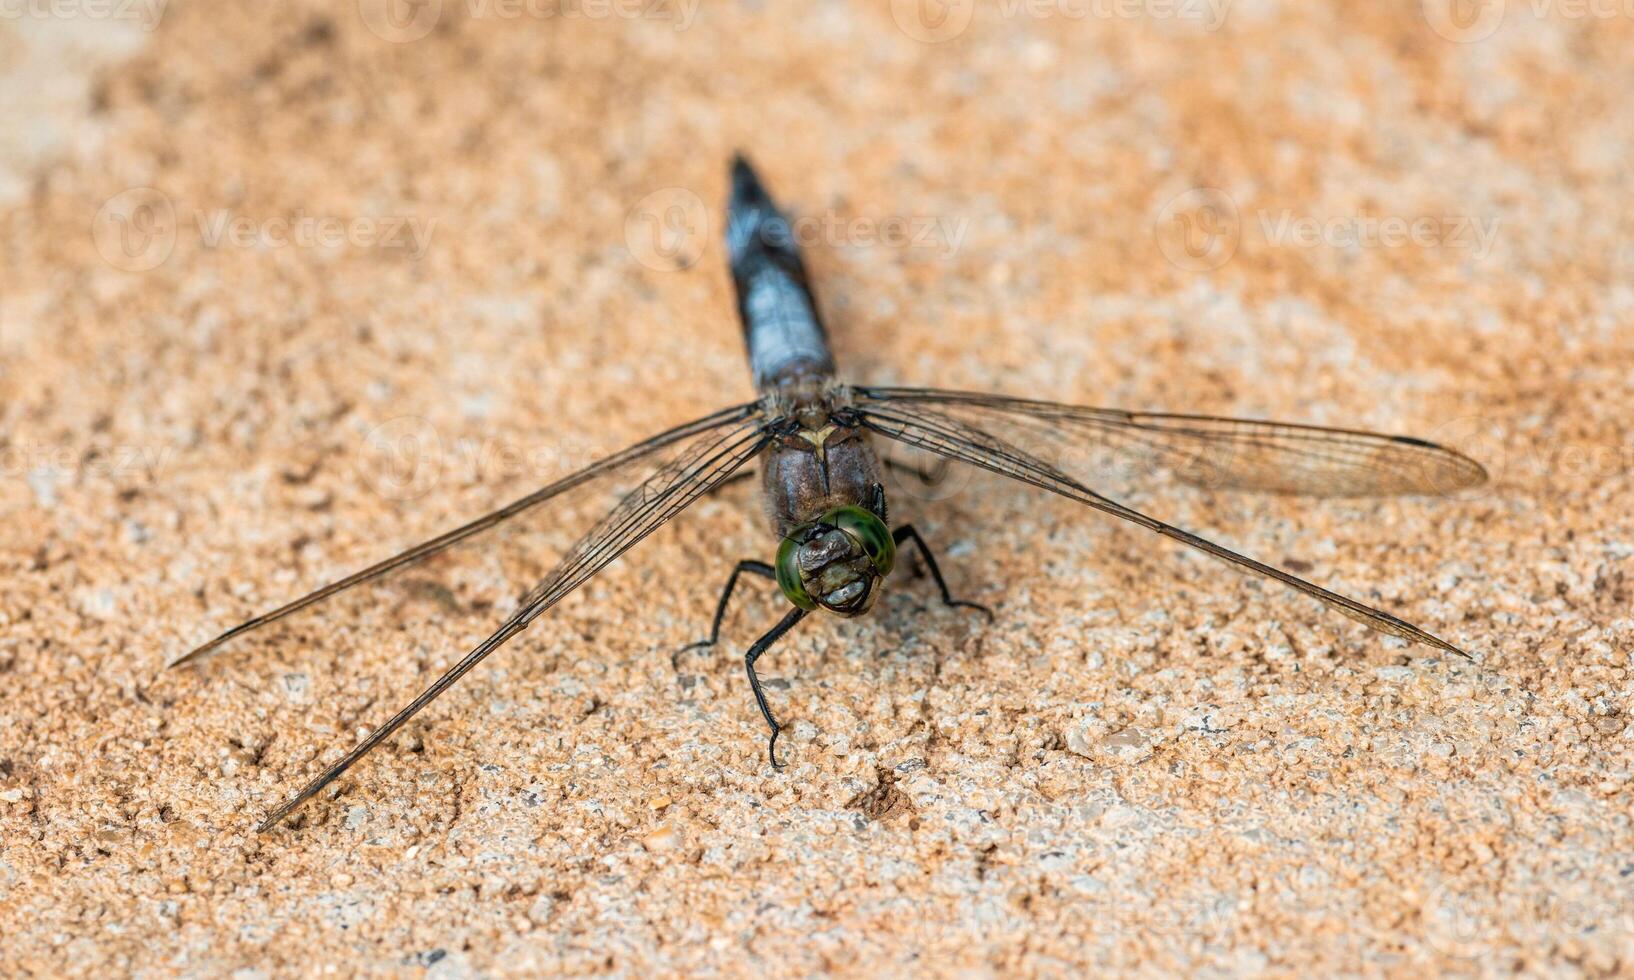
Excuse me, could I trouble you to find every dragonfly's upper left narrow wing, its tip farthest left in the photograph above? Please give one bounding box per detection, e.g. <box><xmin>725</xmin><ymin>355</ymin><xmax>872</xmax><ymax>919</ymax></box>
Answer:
<box><xmin>170</xmin><ymin>403</ymin><xmax>760</xmax><ymax>666</ymax></box>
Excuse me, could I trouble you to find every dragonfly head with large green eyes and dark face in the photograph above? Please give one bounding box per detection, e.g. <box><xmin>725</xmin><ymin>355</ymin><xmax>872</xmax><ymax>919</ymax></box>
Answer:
<box><xmin>778</xmin><ymin>506</ymin><xmax>897</xmax><ymax>616</ymax></box>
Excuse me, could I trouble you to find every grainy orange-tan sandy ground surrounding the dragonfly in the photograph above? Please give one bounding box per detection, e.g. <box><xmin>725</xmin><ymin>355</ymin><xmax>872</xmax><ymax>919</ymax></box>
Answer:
<box><xmin>0</xmin><ymin>0</ymin><xmax>1634</xmax><ymax>977</ymax></box>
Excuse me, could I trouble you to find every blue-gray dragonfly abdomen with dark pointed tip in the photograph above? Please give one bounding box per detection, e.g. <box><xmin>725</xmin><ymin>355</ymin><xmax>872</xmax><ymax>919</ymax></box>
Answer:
<box><xmin>725</xmin><ymin>157</ymin><xmax>833</xmax><ymax>392</ymax></box>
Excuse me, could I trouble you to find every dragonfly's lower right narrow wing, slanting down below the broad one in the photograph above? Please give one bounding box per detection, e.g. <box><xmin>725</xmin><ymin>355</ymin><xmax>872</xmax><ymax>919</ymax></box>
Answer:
<box><xmin>858</xmin><ymin>400</ymin><xmax>1471</xmax><ymax>660</ymax></box>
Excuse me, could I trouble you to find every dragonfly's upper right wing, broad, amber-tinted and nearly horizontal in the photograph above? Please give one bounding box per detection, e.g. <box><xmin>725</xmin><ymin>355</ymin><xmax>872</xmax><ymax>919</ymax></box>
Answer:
<box><xmin>855</xmin><ymin>387</ymin><xmax>1487</xmax><ymax>497</ymax></box>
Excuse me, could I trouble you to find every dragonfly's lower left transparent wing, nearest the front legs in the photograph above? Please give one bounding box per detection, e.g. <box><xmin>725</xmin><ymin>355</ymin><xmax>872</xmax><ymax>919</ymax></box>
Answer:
<box><xmin>258</xmin><ymin>417</ymin><xmax>768</xmax><ymax>831</ymax></box>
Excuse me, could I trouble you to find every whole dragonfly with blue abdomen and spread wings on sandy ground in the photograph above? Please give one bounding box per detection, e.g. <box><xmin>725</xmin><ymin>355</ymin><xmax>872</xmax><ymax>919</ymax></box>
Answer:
<box><xmin>172</xmin><ymin>155</ymin><xmax>1487</xmax><ymax>831</ymax></box>
